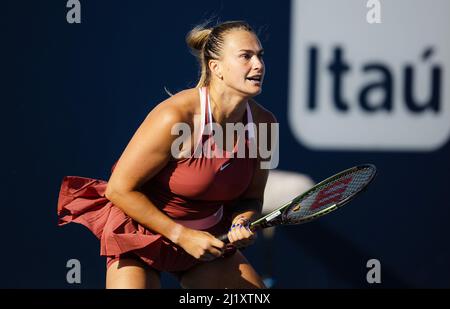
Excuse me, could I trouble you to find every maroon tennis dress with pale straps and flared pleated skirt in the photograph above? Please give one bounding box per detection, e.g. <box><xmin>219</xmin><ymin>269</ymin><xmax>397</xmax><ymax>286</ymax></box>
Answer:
<box><xmin>58</xmin><ymin>88</ymin><xmax>256</xmax><ymax>272</ymax></box>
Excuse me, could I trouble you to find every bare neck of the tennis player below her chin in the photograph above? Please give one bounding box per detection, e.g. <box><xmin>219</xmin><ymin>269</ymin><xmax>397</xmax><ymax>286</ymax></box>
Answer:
<box><xmin>208</xmin><ymin>83</ymin><xmax>248</xmax><ymax>125</ymax></box>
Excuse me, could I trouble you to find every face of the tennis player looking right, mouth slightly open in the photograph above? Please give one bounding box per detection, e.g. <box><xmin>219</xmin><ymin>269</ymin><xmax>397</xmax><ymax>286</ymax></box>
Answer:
<box><xmin>219</xmin><ymin>30</ymin><xmax>265</xmax><ymax>96</ymax></box>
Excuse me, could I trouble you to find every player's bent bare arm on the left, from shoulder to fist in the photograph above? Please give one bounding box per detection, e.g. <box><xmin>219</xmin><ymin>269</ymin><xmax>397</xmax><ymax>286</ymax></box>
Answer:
<box><xmin>105</xmin><ymin>94</ymin><xmax>224</xmax><ymax>260</ymax></box>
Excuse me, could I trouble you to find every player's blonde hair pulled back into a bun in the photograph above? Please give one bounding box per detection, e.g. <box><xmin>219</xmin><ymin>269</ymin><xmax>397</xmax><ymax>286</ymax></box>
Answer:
<box><xmin>186</xmin><ymin>21</ymin><xmax>255</xmax><ymax>88</ymax></box>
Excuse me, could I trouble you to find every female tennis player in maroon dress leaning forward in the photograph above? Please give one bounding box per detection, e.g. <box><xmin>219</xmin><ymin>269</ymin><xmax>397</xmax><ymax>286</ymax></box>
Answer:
<box><xmin>58</xmin><ymin>21</ymin><xmax>276</xmax><ymax>288</ymax></box>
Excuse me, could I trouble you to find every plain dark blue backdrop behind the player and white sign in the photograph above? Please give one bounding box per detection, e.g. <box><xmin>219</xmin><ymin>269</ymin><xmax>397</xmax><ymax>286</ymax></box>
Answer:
<box><xmin>0</xmin><ymin>0</ymin><xmax>450</xmax><ymax>288</ymax></box>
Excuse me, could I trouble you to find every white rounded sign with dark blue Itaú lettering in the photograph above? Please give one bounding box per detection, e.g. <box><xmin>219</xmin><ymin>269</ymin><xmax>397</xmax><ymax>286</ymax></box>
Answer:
<box><xmin>288</xmin><ymin>0</ymin><xmax>450</xmax><ymax>151</ymax></box>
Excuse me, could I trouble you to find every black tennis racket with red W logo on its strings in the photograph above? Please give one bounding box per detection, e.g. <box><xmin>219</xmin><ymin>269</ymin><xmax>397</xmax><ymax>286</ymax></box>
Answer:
<box><xmin>218</xmin><ymin>164</ymin><xmax>377</xmax><ymax>243</ymax></box>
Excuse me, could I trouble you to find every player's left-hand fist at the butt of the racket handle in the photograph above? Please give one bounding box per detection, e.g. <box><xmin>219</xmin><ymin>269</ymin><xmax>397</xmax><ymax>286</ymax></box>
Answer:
<box><xmin>176</xmin><ymin>227</ymin><xmax>225</xmax><ymax>262</ymax></box>
